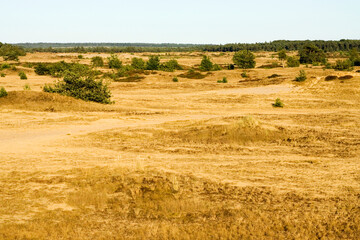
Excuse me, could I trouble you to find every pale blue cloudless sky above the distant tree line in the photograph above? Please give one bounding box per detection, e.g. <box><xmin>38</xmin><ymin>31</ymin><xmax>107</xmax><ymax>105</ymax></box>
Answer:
<box><xmin>0</xmin><ymin>0</ymin><xmax>360</xmax><ymax>44</ymax></box>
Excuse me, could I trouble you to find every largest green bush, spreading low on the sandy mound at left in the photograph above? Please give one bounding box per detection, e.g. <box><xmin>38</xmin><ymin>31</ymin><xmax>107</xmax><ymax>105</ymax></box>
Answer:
<box><xmin>43</xmin><ymin>72</ymin><xmax>111</xmax><ymax>104</ymax></box>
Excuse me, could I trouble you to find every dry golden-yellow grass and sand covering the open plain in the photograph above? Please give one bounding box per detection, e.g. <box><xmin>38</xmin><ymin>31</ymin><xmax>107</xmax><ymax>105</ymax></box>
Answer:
<box><xmin>0</xmin><ymin>53</ymin><xmax>360</xmax><ymax>239</ymax></box>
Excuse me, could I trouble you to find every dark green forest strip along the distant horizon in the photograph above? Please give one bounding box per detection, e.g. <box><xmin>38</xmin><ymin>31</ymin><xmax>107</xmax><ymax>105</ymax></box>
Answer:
<box><xmin>16</xmin><ymin>39</ymin><xmax>360</xmax><ymax>53</ymax></box>
